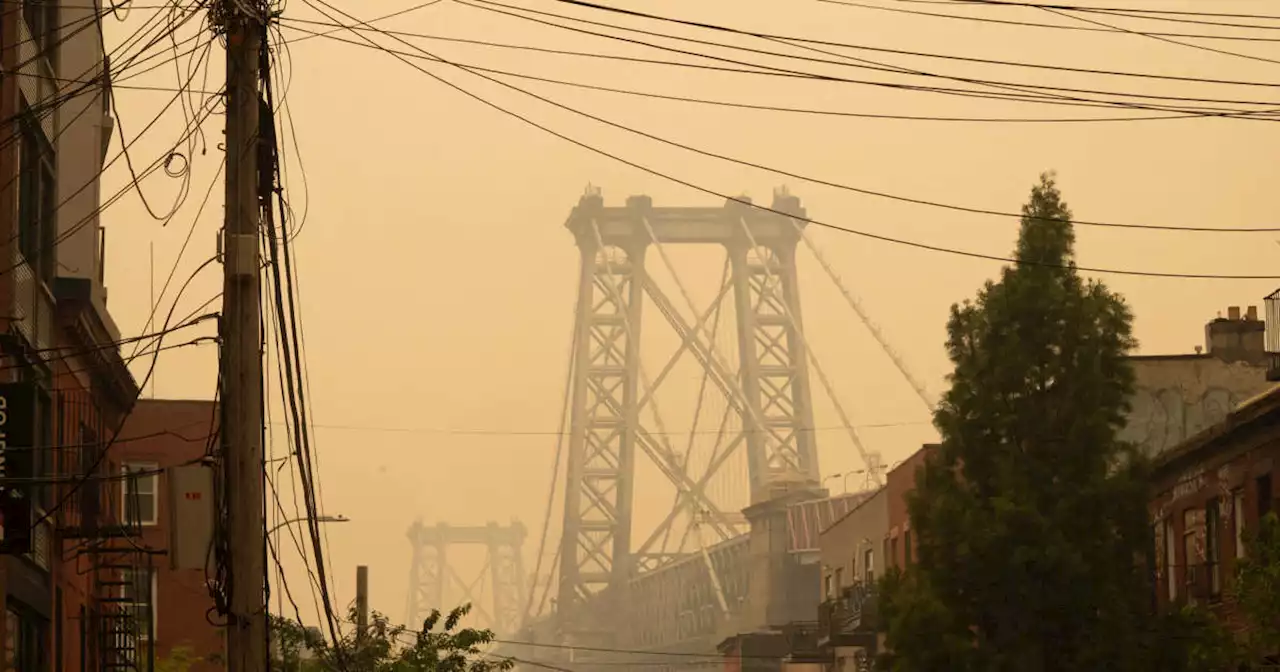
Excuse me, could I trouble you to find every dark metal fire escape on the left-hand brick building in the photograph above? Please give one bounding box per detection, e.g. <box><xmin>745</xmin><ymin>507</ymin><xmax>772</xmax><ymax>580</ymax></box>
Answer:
<box><xmin>59</xmin><ymin>393</ymin><xmax>160</xmax><ymax>672</ymax></box>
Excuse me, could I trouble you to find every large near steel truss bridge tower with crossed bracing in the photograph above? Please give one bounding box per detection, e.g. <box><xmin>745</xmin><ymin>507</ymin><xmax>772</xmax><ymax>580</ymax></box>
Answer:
<box><xmin>557</xmin><ymin>189</ymin><xmax>819</xmax><ymax>639</ymax></box>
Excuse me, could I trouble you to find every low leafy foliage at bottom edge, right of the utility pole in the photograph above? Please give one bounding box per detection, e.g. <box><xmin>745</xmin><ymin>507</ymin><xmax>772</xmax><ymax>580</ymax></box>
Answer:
<box><xmin>271</xmin><ymin>604</ymin><xmax>513</xmax><ymax>672</ymax></box>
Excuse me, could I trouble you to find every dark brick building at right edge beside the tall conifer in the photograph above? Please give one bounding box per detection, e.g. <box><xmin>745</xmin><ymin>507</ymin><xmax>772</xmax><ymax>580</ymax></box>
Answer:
<box><xmin>1151</xmin><ymin>378</ymin><xmax>1280</xmax><ymax>628</ymax></box>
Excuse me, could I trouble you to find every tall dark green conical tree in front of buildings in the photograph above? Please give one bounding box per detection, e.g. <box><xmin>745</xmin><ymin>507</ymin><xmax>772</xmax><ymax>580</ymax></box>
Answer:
<box><xmin>881</xmin><ymin>174</ymin><xmax>1213</xmax><ymax>672</ymax></box>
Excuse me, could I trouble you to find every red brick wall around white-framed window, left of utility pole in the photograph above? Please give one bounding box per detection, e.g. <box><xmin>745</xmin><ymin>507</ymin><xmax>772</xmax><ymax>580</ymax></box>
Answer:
<box><xmin>115</xmin><ymin>399</ymin><xmax>225</xmax><ymax>672</ymax></box>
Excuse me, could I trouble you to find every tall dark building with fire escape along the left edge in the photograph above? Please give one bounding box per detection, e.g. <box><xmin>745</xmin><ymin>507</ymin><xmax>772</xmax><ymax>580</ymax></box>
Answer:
<box><xmin>0</xmin><ymin>0</ymin><xmax>192</xmax><ymax>672</ymax></box>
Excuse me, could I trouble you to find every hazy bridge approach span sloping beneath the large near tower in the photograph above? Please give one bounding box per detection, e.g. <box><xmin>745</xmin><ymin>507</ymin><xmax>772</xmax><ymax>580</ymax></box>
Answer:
<box><xmin>500</xmin><ymin>489</ymin><xmax>872</xmax><ymax>672</ymax></box>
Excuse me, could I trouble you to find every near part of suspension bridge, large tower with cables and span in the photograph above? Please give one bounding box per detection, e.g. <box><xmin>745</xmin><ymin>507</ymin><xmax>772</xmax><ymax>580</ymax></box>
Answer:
<box><xmin>410</xmin><ymin>188</ymin><xmax>934</xmax><ymax>662</ymax></box>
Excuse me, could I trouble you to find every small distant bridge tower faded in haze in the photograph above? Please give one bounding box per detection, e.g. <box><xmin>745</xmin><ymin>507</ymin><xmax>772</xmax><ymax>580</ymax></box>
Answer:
<box><xmin>404</xmin><ymin>521</ymin><xmax>526</xmax><ymax>635</ymax></box>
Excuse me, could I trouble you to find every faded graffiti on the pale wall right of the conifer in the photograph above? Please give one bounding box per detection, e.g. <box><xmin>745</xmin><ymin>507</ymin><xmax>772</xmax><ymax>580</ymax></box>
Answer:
<box><xmin>1120</xmin><ymin>388</ymin><xmax>1243</xmax><ymax>456</ymax></box>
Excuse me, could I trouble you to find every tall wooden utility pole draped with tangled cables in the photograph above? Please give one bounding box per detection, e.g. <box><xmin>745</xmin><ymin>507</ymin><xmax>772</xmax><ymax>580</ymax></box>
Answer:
<box><xmin>220</xmin><ymin>0</ymin><xmax>268</xmax><ymax>672</ymax></box>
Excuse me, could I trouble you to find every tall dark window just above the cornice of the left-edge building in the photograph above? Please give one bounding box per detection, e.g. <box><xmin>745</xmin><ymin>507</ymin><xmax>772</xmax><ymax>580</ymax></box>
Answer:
<box><xmin>18</xmin><ymin>104</ymin><xmax>58</xmax><ymax>285</ymax></box>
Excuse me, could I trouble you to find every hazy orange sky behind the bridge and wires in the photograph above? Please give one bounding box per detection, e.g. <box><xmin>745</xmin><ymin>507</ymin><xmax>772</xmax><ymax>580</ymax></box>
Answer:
<box><xmin>102</xmin><ymin>0</ymin><xmax>1280</xmax><ymax>629</ymax></box>
